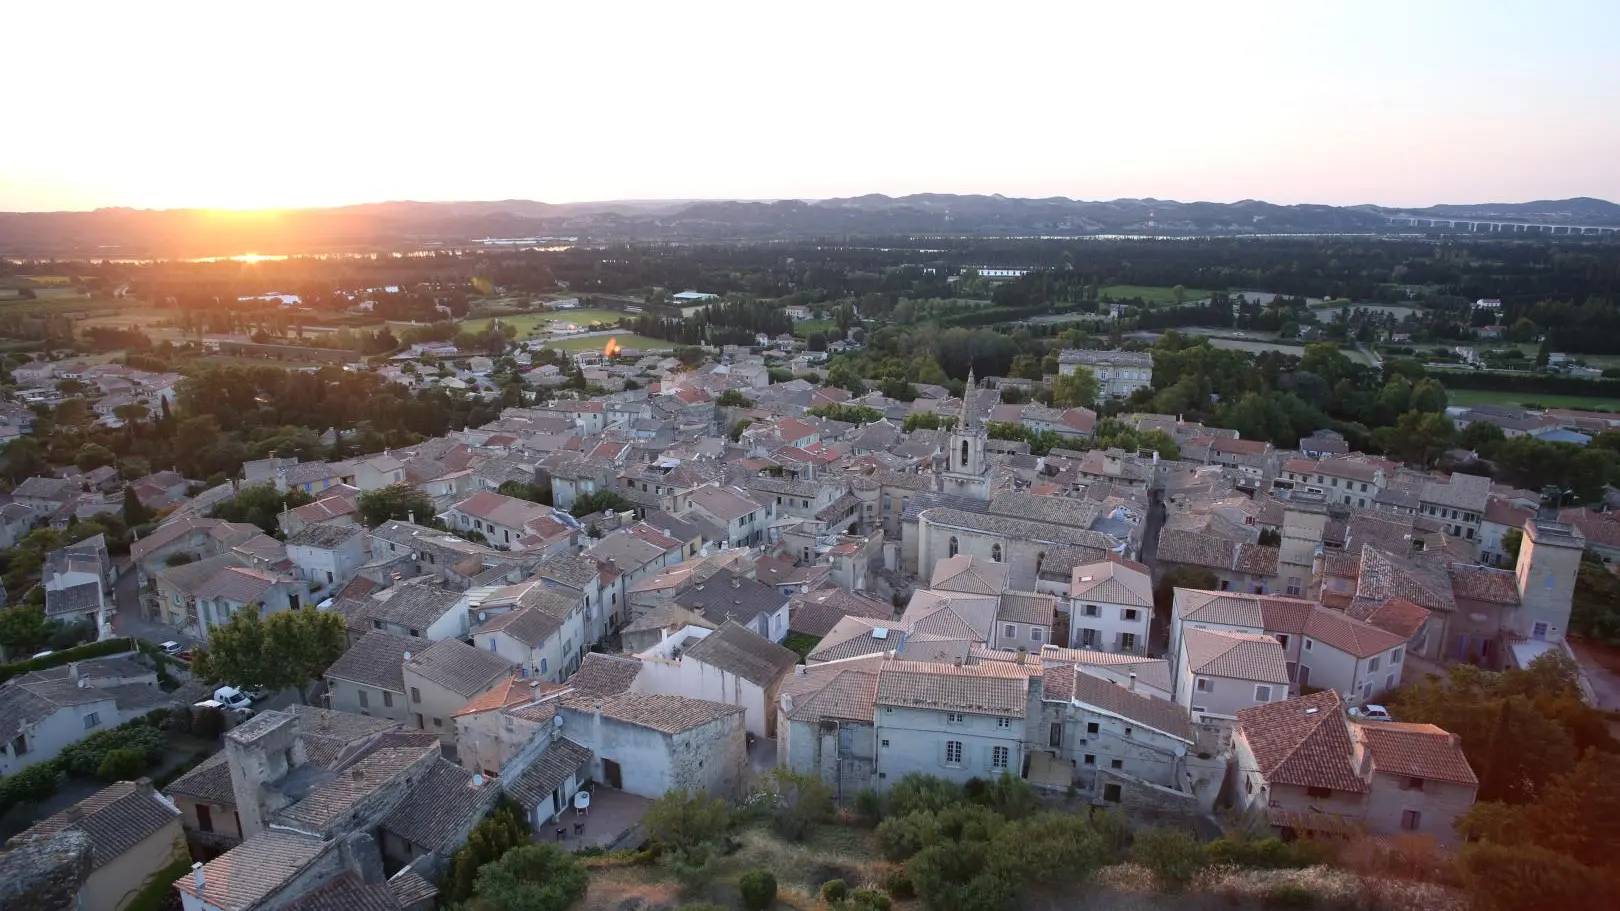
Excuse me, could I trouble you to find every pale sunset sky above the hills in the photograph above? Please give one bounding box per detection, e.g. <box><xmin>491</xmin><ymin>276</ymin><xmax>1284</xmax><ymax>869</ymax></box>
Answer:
<box><xmin>0</xmin><ymin>0</ymin><xmax>1620</xmax><ymax>211</ymax></box>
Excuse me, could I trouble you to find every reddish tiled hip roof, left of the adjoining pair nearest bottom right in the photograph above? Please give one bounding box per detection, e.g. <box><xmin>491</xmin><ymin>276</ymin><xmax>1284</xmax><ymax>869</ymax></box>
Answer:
<box><xmin>1238</xmin><ymin>689</ymin><xmax>1367</xmax><ymax>794</ymax></box>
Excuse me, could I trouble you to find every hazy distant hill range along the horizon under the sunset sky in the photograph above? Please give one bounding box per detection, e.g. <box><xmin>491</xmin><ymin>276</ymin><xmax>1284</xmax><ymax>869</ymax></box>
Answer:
<box><xmin>0</xmin><ymin>193</ymin><xmax>1620</xmax><ymax>256</ymax></box>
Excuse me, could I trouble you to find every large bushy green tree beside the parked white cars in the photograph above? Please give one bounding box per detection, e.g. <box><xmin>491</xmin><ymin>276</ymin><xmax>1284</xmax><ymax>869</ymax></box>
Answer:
<box><xmin>191</xmin><ymin>606</ymin><xmax>347</xmax><ymax>700</ymax></box>
